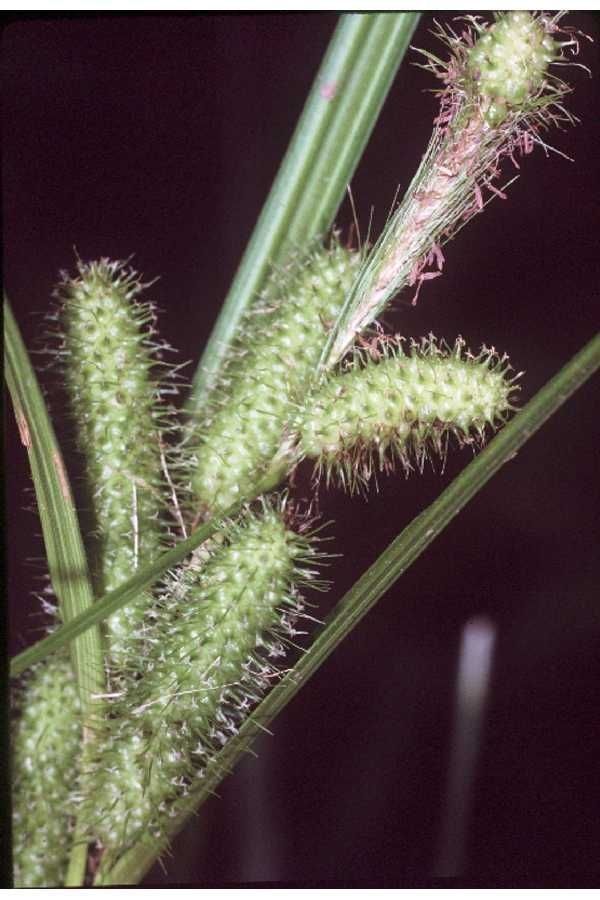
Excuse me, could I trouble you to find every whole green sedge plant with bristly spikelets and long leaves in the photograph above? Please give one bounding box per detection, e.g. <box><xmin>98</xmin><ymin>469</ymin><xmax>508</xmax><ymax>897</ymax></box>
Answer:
<box><xmin>7</xmin><ymin>12</ymin><xmax>600</xmax><ymax>887</ymax></box>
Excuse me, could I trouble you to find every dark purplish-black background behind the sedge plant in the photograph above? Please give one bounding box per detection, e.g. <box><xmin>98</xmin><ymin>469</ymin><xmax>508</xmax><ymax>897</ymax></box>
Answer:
<box><xmin>3</xmin><ymin>13</ymin><xmax>600</xmax><ymax>884</ymax></box>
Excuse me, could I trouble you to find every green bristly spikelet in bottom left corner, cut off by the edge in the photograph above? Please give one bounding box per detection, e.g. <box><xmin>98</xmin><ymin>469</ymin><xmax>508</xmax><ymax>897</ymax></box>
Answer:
<box><xmin>12</xmin><ymin>657</ymin><xmax>81</xmax><ymax>888</ymax></box>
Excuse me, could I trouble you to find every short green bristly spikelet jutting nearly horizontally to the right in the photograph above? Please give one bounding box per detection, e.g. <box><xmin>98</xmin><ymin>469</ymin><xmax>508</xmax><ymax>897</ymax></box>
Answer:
<box><xmin>298</xmin><ymin>337</ymin><xmax>514</xmax><ymax>489</ymax></box>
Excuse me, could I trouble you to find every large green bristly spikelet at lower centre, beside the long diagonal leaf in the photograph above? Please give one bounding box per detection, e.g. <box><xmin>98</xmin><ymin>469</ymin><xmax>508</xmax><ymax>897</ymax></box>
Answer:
<box><xmin>82</xmin><ymin>503</ymin><xmax>319</xmax><ymax>852</ymax></box>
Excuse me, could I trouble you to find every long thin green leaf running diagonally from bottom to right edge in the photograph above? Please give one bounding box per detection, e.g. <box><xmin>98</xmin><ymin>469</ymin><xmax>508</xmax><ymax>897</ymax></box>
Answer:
<box><xmin>96</xmin><ymin>333</ymin><xmax>600</xmax><ymax>886</ymax></box>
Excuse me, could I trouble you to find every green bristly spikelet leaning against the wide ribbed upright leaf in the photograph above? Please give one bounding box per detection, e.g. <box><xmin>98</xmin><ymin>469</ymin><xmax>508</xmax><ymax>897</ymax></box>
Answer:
<box><xmin>191</xmin><ymin>240</ymin><xmax>360</xmax><ymax>513</ymax></box>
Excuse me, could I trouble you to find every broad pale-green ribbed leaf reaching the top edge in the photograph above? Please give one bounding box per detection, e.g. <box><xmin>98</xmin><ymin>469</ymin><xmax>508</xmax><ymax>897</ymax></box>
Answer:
<box><xmin>187</xmin><ymin>12</ymin><xmax>420</xmax><ymax>415</ymax></box>
